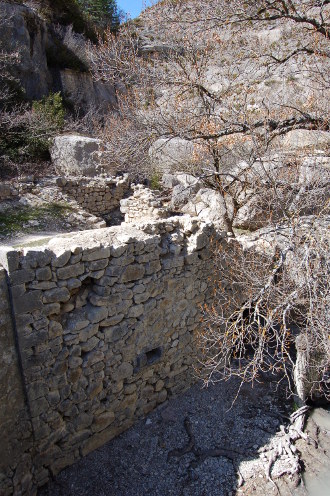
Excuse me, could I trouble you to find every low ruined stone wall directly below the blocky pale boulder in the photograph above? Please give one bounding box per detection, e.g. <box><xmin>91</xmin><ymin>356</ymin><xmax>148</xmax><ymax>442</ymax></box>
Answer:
<box><xmin>57</xmin><ymin>174</ymin><xmax>129</xmax><ymax>215</ymax></box>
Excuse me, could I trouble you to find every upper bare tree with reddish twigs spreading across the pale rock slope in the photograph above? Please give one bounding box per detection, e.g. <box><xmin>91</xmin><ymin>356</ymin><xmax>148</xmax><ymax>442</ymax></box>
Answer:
<box><xmin>93</xmin><ymin>0</ymin><xmax>329</xmax><ymax>224</ymax></box>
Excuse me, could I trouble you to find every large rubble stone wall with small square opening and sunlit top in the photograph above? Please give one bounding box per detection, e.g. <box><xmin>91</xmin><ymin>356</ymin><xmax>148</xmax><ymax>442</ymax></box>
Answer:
<box><xmin>0</xmin><ymin>216</ymin><xmax>222</xmax><ymax>494</ymax></box>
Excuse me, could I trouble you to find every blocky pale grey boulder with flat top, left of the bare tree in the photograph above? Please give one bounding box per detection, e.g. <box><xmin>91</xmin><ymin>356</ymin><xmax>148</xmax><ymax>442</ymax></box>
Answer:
<box><xmin>51</xmin><ymin>135</ymin><xmax>102</xmax><ymax>176</ymax></box>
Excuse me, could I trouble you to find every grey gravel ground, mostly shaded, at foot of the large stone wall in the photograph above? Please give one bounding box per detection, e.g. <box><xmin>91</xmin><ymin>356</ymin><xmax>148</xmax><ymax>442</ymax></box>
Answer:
<box><xmin>38</xmin><ymin>381</ymin><xmax>330</xmax><ymax>496</ymax></box>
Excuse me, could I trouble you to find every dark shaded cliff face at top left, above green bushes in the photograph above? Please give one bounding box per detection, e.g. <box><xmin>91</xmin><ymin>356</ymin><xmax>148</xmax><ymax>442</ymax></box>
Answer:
<box><xmin>0</xmin><ymin>1</ymin><xmax>116</xmax><ymax>113</ymax></box>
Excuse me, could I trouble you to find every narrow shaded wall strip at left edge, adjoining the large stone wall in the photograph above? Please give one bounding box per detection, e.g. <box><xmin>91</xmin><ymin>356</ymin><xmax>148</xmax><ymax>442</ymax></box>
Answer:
<box><xmin>0</xmin><ymin>265</ymin><xmax>33</xmax><ymax>496</ymax></box>
